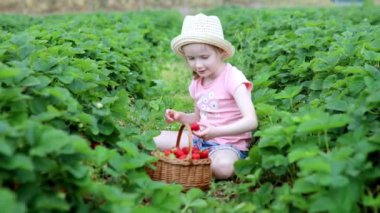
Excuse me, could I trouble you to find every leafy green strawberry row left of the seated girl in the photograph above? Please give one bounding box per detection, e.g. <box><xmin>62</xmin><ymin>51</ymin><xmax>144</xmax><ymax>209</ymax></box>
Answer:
<box><xmin>0</xmin><ymin>11</ymin><xmax>191</xmax><ymax>212</ymax></box>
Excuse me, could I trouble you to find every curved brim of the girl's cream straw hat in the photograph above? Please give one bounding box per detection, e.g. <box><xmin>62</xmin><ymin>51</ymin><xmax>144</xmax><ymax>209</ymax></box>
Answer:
<box><xmin>171</xmin><ymin>35</ymin><xmax>235</xmax><ymax>58</ymax></box>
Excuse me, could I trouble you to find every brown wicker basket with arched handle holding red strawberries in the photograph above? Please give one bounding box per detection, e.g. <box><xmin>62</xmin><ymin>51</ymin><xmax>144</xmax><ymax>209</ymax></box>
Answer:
<box><xmin>147</xmin><ymin>125</ymin><xmax>211</xmax><ymax>190</ymax></box>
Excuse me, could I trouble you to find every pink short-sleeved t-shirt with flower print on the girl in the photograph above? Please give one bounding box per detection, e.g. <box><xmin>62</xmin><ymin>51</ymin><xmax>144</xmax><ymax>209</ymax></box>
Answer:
<box><xmin>189</xmin><ymin>63</ymin><xmax>252</xmax><ymax>150</ymax></box>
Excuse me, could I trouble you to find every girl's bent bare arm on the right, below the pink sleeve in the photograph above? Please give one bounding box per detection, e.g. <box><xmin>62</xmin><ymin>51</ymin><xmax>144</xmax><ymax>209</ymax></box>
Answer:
<box><xmin>194</xmin><ymin>84</ymin><xmax>258</xmax><ymax>140</ymax></box>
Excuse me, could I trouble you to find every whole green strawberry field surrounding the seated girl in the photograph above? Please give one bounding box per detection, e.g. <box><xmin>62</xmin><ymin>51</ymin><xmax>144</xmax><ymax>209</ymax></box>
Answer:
<box><xmin>0</xmin><ymin>7</ymin><xmax>380</xmax><ymax>212</ymax></box>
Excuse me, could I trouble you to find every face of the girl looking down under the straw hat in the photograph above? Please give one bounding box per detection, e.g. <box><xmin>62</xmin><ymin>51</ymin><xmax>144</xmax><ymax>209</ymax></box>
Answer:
<box><xmin>182</xmin><ymin>43</ymin><xmax>224</xmax><ymax>79</ymax></box>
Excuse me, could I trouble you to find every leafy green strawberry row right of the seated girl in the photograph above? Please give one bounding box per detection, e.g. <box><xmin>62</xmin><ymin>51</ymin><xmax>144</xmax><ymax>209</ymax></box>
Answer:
<box><xmin>214</xmin><ymin>7</ymin><xmax>380</xmax><ymax>212</ymax></box>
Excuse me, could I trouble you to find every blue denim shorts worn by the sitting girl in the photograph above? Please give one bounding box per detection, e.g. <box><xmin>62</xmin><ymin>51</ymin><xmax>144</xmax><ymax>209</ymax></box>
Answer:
<box><xmin>193</xmin><ymin>137</ymin><xmax>248</xmax><ymax>159</ymax></box>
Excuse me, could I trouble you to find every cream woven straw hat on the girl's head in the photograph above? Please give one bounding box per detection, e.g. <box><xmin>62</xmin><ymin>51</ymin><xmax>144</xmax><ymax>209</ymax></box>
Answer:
<box><xmin>171</xmin><ymin>13</ymin><xmax>235</xmax><ymax>58</ymax></box>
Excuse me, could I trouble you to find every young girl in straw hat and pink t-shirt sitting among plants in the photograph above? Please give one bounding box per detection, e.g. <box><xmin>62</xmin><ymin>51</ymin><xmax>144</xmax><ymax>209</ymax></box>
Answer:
<box><xmin>154</xmin><ymin>14</ymin><xmax>258</xmax><ymax>179</ymax></box>
